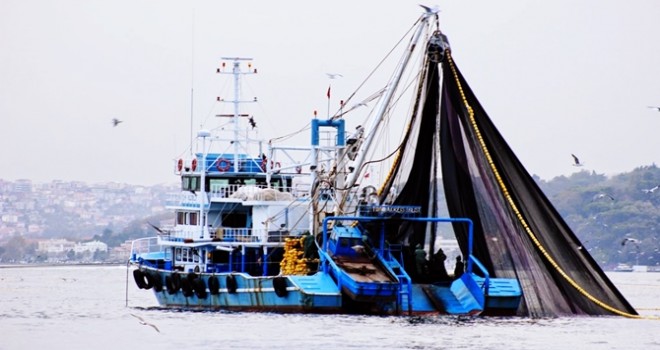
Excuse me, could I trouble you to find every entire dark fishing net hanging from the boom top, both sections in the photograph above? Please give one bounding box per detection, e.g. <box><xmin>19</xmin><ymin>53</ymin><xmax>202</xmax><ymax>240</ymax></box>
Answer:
<box><xmin>380</xmin><ymin>30</ymin><xmax>637</xmax><ymax>317</ymax></box>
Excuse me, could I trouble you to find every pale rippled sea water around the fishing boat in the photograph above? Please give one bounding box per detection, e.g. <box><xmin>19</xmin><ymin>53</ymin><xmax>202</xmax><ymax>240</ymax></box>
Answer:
<box><xmin>0</xmin><ymin>266</ymin><xmax>660</xmax><ymax>350</ymax></box>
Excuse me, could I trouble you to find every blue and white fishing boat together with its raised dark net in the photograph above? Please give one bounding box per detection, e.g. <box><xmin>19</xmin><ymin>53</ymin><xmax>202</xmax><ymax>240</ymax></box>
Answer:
<box><xmin>129</xmin><ymin>8</ymin><xmax>635</xmax><ymax>316</ymax></box>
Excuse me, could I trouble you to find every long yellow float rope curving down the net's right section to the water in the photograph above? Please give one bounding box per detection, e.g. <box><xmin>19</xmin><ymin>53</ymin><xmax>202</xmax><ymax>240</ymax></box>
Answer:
<box><xmin>446</xmin><ymin>51</ymin><xmax>660</xmax><ymax>320</ymax></box>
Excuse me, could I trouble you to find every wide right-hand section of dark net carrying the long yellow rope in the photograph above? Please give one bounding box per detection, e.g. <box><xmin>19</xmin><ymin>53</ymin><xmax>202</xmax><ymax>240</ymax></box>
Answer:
<box><xmin>440</xmin><ymin>52</ymin><xmax>637</xmax><ymax>317</ymax></box>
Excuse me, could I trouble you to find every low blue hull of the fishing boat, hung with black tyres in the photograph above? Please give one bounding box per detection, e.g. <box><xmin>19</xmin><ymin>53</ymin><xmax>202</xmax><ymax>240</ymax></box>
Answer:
<box><xmin>131</xmin><ymin>268</ymin><xmax>520</xmax><ymax>315</ymax></box>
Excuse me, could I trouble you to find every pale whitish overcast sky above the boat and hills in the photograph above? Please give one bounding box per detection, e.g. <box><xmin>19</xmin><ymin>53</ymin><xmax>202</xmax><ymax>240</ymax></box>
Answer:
<box><xmin>0</xmin><ymin>0</ymin><xmax>660</xmax><ymax>185</ymax></box>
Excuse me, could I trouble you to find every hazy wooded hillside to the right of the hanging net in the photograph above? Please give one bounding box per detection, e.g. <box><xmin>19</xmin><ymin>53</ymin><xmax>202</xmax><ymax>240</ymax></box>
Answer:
<box><xmin>537</xmin><ymin>165</ymin><xmax>660</xmax><ymax>266</ymax></box>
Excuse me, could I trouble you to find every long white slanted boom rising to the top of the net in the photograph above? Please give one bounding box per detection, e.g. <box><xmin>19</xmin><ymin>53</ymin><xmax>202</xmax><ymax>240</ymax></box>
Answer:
<box><xmin>338</xmin><ymin>11</ymin><xmax>436</xmax><ymax>214</ymax></box>
